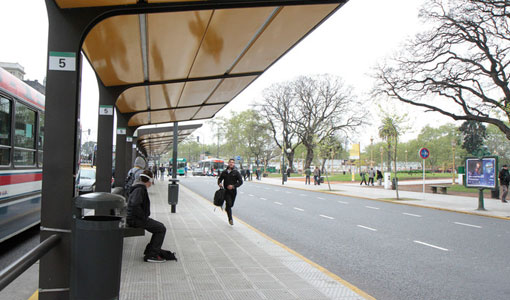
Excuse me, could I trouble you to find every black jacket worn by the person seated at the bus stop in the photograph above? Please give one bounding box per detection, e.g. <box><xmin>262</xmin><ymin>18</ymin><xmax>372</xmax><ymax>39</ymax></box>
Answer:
<box><xmin>126</xmin><ymin>184</ymin><xmax>151</xmax><ymax>224</ymax></box>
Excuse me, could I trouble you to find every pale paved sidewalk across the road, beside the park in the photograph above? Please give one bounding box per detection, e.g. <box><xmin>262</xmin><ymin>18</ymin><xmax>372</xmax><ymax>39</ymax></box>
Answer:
<box><xmin>253</xmin><ymin>177</ymin><xmax>510</xmax><ymax>220</ymax></box>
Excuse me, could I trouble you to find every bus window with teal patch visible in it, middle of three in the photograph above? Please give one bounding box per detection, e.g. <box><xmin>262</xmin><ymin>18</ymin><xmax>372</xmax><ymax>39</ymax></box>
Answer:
<box><xmin>14</xmin><ymin>103</ymin><xmax>36</xmax><ymax>166</ymax></box>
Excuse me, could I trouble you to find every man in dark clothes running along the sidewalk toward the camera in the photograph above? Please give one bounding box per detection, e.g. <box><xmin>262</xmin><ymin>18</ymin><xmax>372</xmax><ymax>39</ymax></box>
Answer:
<box><xmin>218</xmin><ymin>158</ymin><xmax>243</xmax><ymax>225</ymax></box>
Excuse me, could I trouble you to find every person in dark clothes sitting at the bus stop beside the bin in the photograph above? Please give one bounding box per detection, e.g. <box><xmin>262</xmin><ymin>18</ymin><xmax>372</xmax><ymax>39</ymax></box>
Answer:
<box><xmin>126</xmin><ymin>170</ymin><xmax>177</xmax><ymax>262</ymax></box>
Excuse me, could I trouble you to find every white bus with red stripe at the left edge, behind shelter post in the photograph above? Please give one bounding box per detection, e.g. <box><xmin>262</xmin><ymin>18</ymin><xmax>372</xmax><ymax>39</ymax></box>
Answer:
<box><xmin>0</xmin><ymin>68</ymin><xmax>44</xmax><ymax>242</ymax></box>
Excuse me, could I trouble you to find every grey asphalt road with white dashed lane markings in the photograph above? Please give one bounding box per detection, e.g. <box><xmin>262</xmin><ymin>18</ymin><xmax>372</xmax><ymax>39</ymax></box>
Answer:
<box><xmin>181</xmin><ymin>177</ymin><xmax>510</xmax><ymax>300</ymax></box>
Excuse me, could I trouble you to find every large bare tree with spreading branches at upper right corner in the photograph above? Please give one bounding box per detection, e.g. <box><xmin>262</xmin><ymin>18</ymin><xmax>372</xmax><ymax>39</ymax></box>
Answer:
<box><xmin>374</xmin><ymin>0</ymin><xmax>510</xmax><ymax>139</ymax></box>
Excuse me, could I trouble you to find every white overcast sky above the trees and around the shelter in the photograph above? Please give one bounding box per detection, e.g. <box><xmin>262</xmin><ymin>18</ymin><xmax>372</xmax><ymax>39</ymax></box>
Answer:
<box><xmin>0</xmin><ymin>0</ymin><xmax>451</xmax><ymax>147</ymax></box>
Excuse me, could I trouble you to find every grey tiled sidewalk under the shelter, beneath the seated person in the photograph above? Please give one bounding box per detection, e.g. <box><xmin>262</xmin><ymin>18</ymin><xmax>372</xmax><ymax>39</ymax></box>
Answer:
<box><xmin>120</xmin><ymin>181</ymin><xmax>373</xmax><ymax>300</ymax></box>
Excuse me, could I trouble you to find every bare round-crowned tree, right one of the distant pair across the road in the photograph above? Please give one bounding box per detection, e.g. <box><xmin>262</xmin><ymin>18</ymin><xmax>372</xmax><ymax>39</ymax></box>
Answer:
<box><xmin>291</xmin><ymin>75</ymin><xmax>367</xmax><ymax>169</ymax></box>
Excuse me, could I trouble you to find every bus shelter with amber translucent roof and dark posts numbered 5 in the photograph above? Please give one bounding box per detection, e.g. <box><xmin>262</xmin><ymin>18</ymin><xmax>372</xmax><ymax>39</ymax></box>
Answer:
<box><xmin>39</xmin><ymin>0</ymin><xmax>347</xmax><ymax>300</ymax></box>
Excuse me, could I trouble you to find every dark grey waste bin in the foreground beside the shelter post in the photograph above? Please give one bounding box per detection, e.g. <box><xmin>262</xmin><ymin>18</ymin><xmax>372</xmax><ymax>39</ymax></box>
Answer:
<box><xmin>71</xmin><ymin>193</ymin><xmax>125</xmax><ymax>300</ymax></box>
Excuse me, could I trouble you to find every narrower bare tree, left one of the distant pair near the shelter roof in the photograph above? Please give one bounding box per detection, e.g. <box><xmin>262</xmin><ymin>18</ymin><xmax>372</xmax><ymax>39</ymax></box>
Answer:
<box><xmin>258</xmin><ymin>83</ymin><xmax>301</xmax><ymax>168</ymax></box>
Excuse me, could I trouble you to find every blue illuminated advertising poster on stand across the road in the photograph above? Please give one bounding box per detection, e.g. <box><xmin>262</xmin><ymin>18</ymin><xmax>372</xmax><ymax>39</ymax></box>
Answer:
<box><xmin>466</xmin><ymin>157</ymin><xmax>496</xmax><ymax>189</ymax></box>
